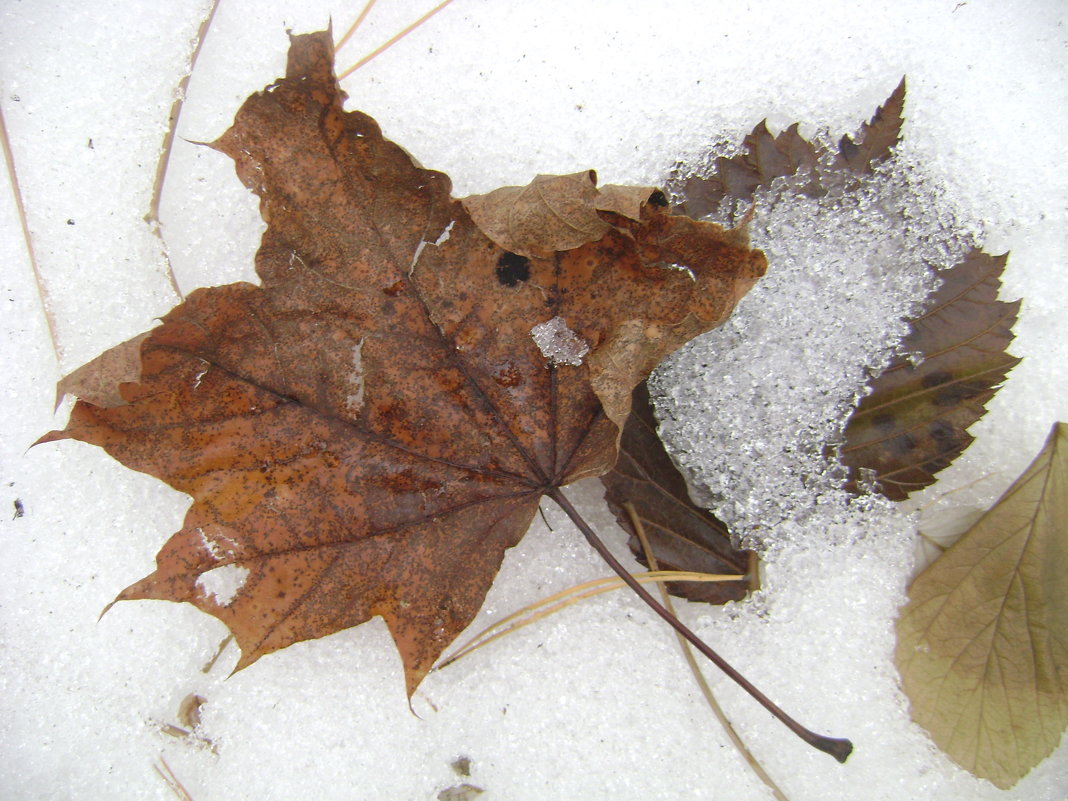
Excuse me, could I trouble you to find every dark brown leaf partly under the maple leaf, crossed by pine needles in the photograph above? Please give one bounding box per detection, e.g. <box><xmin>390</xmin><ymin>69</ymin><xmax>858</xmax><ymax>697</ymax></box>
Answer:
<box><xmin>601</xmin><ymin>381</ymin><xmax>757</xmax><ymax>603</ymax></box>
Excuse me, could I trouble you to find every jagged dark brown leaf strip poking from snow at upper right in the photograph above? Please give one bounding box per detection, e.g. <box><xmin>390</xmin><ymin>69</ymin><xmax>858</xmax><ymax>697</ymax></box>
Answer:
<box><xmin>669</xmin><ymin>78</ymin><xmax>906</xmax><ymax>219</ymax></box>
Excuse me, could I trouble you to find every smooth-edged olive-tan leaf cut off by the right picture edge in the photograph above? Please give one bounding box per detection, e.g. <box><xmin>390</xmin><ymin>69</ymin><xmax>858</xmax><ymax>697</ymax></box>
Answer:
<box><xmin>897</xmin><ymin>423</ymin><xmax>1068</xmax><ymax>789</ymax></box>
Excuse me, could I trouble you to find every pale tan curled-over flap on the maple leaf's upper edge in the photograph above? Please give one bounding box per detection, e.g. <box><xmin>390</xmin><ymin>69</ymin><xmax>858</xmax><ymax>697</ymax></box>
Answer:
<box><xmin>460</xmin><ymin>170</ymin><xmax>657</xmax><ymax>258</ymax></box>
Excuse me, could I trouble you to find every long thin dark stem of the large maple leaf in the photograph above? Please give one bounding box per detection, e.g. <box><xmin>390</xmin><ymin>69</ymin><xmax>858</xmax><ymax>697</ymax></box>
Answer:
<box><xmin>546</xmin><ymin>487</ymin><xmax>853</xmax><ymax>763</ymax></box>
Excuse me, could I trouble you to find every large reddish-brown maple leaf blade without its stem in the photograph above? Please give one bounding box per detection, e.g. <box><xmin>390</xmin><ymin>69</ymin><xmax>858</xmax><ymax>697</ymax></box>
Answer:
<box><xmin>44</xmin><ymin>32</ymin><xmax>765</xmax><ymax>695</ymax></box>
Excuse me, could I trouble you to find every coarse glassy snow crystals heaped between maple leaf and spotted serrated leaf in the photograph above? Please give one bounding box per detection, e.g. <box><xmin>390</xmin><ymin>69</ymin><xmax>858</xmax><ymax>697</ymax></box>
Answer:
<box><xmin>653</xmin><ymin>164</ymin><xmax>971</xmax><ymax>546</ymax></box>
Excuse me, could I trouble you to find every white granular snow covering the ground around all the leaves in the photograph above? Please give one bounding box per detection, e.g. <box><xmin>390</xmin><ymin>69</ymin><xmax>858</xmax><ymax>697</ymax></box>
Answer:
<box><xmin>0</xmin><ymin>0</ymin><xmax>1068</xmax><ymax>801</ymax></box>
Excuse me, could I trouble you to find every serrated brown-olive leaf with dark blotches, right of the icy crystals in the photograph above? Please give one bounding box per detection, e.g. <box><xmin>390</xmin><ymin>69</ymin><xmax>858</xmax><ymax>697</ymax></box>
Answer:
<box><xmin>839</xmin><ymin>250</ymin><xmax>1020</xmax><ymax>501</ymax></box>
